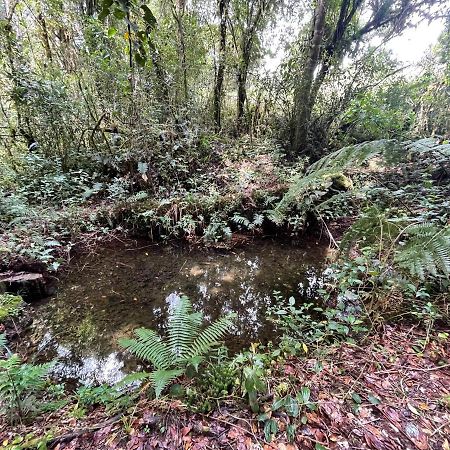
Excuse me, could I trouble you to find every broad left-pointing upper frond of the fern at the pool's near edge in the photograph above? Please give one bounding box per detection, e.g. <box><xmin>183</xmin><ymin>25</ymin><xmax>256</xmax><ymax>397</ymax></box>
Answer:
<box><xmin>119</xmin><ymin>328</ymin><xmax>172</xmax><ymax>369</ymax></box>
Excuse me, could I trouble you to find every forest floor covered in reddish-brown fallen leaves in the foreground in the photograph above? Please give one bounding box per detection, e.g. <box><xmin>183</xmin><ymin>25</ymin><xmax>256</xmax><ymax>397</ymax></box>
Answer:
<box><xmin>0</xmin><ymin>326</ymin><xmax>450</xmax><ymax>450</ymax></box>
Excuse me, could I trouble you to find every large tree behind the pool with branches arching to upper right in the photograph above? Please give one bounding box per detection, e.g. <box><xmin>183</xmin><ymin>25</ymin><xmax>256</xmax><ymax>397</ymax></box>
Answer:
<box><xmin>291</xmin><ymin>0</ymin><xmax>445</xmax><ymax>156</ymax></box>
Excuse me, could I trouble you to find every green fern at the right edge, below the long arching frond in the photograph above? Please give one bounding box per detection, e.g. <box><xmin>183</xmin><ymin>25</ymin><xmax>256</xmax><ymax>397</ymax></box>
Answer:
<box><xmin>394</xmin><ymin>223</ymin><xmax>450</xmax><ymax>280</ymax></box>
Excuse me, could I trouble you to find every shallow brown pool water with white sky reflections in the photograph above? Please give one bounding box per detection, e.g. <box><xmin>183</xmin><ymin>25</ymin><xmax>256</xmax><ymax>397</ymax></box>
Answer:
<box><xmin>30</xmin><ymin>241</ymin><xmax>326</xmax><ymax>384</ymax></box>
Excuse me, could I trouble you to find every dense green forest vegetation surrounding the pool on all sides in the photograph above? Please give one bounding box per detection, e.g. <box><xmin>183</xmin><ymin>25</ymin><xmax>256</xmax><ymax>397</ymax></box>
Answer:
<box><xmin>0</xmin><ymin>0</ymin><xmax>450</xmax><ymax>450</ymax></box>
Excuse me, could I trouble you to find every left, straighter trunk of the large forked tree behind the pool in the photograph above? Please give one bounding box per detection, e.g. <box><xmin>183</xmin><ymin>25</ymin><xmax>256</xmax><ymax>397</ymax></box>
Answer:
<box><xmin>291</xmin><ymin>0</ymin><xmax>326</xmax><ymax>153</ymax></box>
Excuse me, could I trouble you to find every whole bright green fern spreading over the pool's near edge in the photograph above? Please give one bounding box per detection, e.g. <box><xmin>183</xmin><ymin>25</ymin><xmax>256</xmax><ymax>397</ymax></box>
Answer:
<box><xmin>119</xmin><ymin>296</ymin><xmax>233</xmax><ymax>397</ymax></box>
